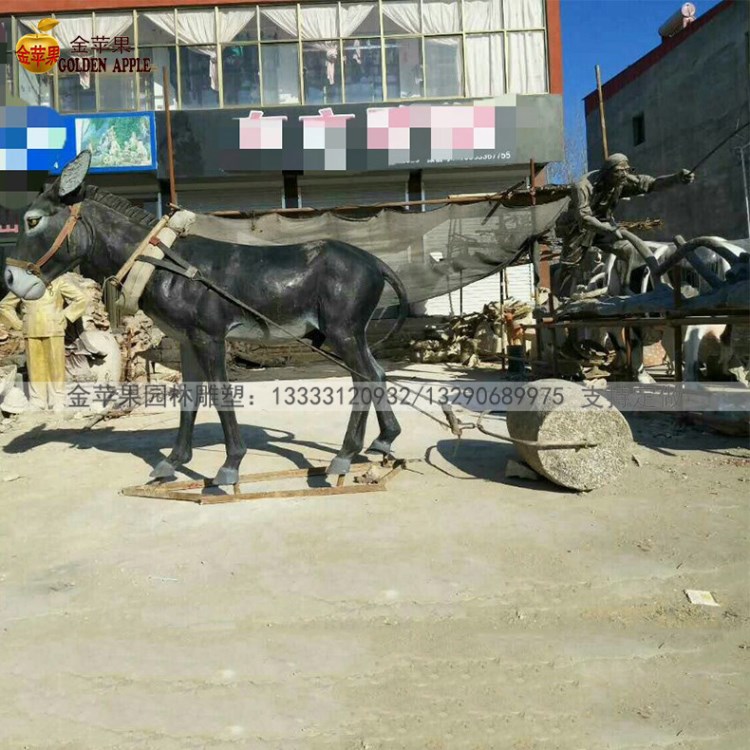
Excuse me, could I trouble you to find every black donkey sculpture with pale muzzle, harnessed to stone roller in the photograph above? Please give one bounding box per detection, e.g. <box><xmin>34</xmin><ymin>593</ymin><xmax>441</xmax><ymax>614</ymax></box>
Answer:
<box><xmin>5</xmin><ymin>151</ymin><xmax>408</xmax><ymax>485</ymax></box>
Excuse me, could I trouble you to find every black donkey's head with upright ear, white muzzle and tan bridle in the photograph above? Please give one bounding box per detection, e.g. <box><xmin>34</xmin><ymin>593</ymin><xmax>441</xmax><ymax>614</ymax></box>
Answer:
<box><xmin>5</xmin><ymin>151</ymin><xmax>91</xmax><ymax>300</ymax></box>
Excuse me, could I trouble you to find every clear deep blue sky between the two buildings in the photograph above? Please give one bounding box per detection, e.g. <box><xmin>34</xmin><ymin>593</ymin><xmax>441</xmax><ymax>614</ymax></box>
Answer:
<box><xmin>560</xmin><ymin>0</ymin><xmax>721</xmax><ymax>176</ymax></box>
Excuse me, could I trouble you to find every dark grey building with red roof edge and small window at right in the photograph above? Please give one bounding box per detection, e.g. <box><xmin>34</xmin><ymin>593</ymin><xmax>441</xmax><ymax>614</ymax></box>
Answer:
<box><xmin>585</xmin><ymin>0</ymin><xmax>750</xmax><ymax>241</ymax></box>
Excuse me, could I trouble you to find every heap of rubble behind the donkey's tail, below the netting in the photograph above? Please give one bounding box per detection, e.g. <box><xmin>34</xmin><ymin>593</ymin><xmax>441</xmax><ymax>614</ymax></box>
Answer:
<box><xmin>409</xmin><ymin>298</ymin><xmax>534</xmax><ymax>367</ymax></box>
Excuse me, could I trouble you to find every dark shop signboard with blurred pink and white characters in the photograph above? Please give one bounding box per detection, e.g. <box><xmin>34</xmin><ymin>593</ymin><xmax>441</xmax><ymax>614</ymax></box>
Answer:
<box><xmin>157</xmin><ymin>96</ymin><xmax>562</xmax><ymax>178</ymax></box>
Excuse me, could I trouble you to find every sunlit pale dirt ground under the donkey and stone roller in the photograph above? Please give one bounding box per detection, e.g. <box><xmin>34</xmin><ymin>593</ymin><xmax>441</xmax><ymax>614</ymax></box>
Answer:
<box><xmin>0</xmin><ymin>366</ymin><xmax>750</xmax><ymax>750</ymax></box>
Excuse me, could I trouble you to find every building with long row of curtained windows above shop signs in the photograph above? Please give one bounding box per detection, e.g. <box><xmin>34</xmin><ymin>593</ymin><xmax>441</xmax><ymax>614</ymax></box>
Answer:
<box><xmin>2</xmin><ymin>0</ymin><xmax>563</xmax><ymax>310</ymax></box>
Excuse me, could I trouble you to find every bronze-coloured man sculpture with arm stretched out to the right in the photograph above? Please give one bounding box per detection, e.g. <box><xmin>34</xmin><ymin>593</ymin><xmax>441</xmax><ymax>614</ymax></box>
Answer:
<box><xmin>555</xmin><ymin>154</ymin><xmax>695</xmax><ymax>296</ymax></box>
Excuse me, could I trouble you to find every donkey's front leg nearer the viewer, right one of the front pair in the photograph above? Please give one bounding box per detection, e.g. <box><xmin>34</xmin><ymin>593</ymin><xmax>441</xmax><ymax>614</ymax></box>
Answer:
<box><xmin>193</xmin><ymin>337</ymin><xmax>247</xmax><ymax>485</ymax></box>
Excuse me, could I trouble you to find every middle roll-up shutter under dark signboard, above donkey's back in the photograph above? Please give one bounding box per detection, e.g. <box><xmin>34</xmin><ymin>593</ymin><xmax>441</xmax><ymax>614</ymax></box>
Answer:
<box><xmin>299</xmin><ymin>172</ymin><xmax>409</xmax><ymax>208</ymax></box>
